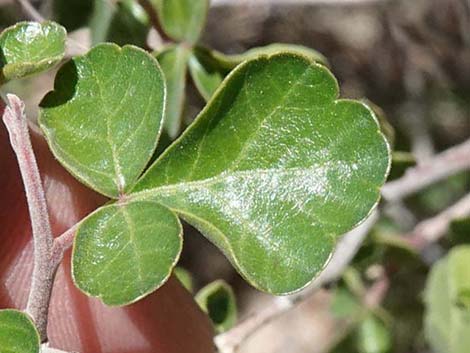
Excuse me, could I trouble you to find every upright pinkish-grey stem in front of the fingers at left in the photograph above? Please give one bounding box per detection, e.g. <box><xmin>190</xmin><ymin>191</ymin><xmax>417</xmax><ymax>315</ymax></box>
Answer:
<box><xmin>3</xmin><ymin>94</ymin><xmax>56</xmax><ymax>341</ymax></box>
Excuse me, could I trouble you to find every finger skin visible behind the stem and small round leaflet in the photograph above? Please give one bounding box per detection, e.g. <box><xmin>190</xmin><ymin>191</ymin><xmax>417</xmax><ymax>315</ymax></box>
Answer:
<box><xmin>0</xmin><ymin>113</ymin><xmax>214</xmax><ymax>353</ymax></box>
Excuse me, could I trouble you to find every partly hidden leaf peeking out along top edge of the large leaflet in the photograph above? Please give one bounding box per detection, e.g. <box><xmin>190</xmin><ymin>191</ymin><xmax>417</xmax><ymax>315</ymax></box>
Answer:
<box><xmin>189</xmin><ymin>43</ymin><xmax>328</xmax><ymax>101</ymax></box>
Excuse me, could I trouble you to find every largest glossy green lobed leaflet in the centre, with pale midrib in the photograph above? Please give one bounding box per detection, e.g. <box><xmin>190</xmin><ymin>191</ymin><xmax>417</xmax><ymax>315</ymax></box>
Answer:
<box><xmin>133</xmin><ymin>53</ymin><xmax>389</xmax><ymax>294</ymax></box>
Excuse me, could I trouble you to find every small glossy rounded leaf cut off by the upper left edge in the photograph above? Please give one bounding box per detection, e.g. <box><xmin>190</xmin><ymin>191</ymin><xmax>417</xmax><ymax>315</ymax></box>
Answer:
<box><xmin>0</xmin><ymin>22</ymin><xmax>67</xmax><ymax>82</ymax></box>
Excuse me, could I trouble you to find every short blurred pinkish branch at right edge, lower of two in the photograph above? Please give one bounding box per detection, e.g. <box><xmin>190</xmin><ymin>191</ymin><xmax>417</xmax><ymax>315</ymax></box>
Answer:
<box><xmin>408</xmin><ymin>194</ymin><xmax>470</xmax><ymax>250</ymax></box>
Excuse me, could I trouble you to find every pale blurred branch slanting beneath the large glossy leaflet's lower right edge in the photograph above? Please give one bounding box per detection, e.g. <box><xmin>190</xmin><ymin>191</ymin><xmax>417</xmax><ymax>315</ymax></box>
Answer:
<box><xmin>214</xmin><ymin>211</ymin><xmax>378</xmax><ymax>353</ymax></box>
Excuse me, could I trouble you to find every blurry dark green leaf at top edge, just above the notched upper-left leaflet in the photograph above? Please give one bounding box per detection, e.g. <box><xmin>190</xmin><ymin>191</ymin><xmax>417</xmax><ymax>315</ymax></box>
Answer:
<box><xmin>90</xmin><ymin>0</ymin><xmax>150</xmax><ymax>47</ymax></box>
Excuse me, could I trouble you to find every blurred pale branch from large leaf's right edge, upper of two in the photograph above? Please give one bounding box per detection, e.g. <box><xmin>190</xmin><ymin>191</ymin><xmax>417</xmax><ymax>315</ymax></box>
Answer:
<box><xmin>382</xmin><ymin>139</ymin><xmax>470</xmax><ymax>202</ymax></box>
